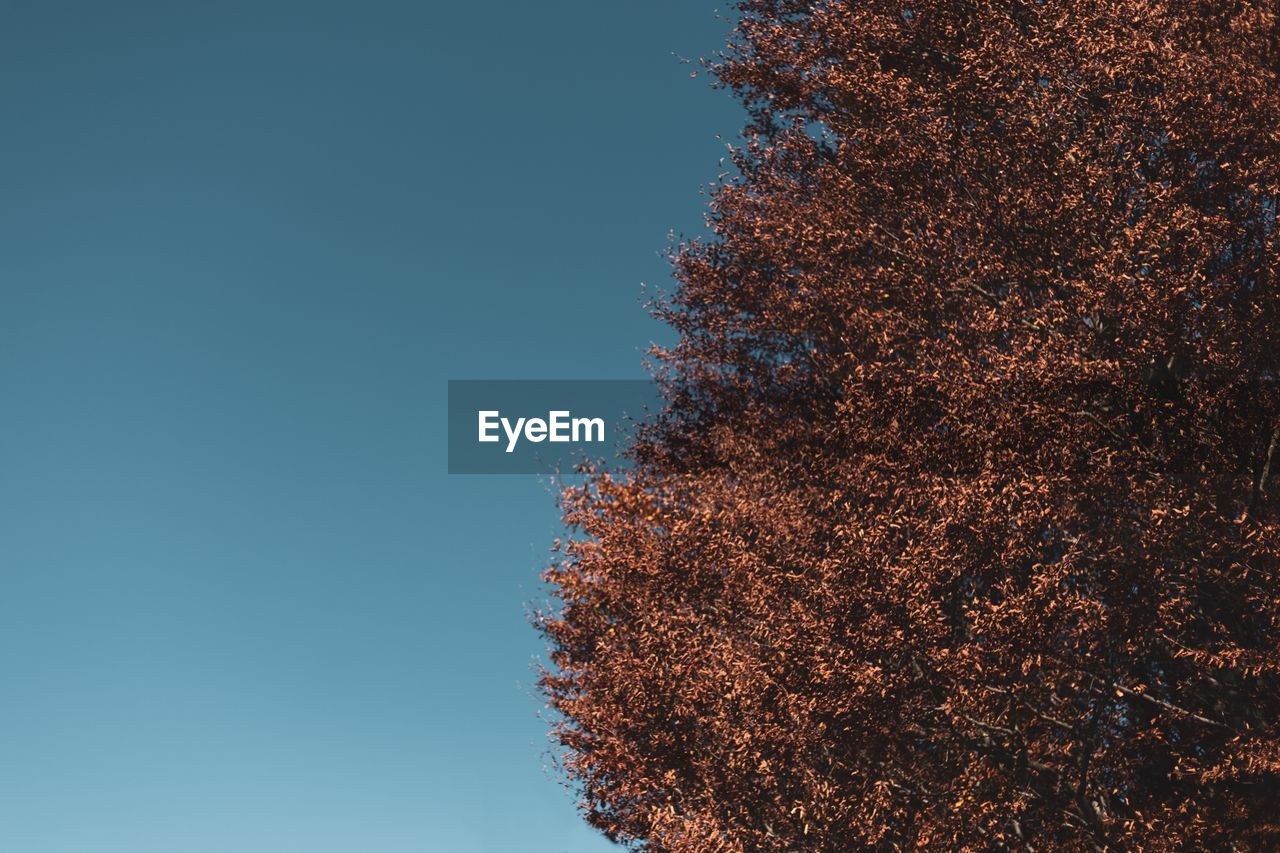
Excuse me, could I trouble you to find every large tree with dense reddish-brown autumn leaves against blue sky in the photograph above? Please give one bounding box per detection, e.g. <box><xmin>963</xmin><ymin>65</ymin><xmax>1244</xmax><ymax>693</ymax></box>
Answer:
<box><xmin>538</xmin><ymin>0</ymin><xmax>1280</xmax><ymax>852</ymax></box>
